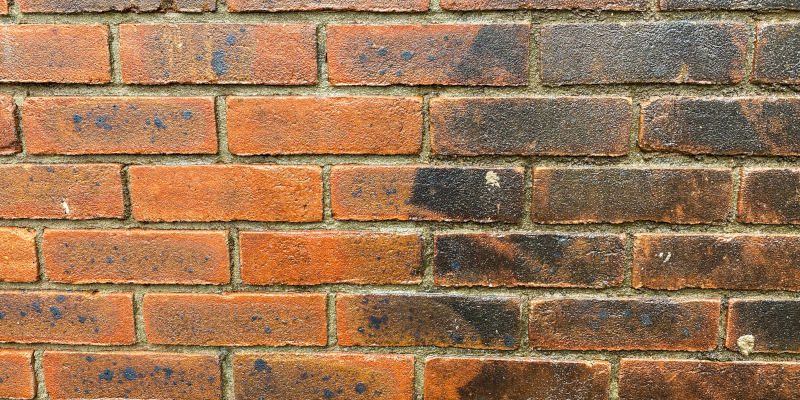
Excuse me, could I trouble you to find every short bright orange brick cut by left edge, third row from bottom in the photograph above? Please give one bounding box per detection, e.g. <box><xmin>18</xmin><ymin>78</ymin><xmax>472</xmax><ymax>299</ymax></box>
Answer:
<box><xmin>0</xmin><ymin>228</ymin><xmax>39</xmax><ymax>282</ymax></box>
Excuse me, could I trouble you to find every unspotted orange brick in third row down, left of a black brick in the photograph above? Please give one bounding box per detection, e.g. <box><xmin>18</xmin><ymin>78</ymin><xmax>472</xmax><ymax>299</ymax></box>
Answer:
<box><xmin>227</xmin><ymin>96</ymin><xmax>422</xmax><ymax>155</ymax></box>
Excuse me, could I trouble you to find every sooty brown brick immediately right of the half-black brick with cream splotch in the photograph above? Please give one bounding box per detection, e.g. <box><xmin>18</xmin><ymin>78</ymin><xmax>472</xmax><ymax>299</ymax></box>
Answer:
<box><xmin>532</xmin><ymin>167</ymin><xmax>733</xmax><ymax>224</ymax></box>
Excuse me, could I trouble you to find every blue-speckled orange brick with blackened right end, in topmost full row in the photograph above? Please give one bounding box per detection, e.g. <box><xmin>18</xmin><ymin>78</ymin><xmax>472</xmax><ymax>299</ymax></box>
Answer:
<box><xmin>327</xmin><ymin>24</ymin><xmax>530</xmax><ymax>86</ymax></box>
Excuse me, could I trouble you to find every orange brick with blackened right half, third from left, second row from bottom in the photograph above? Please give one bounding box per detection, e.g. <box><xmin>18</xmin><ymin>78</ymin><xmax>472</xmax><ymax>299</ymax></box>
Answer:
<box><xmin>336</xmin><ymin>293</ymin><xmax>520</xmax><ymax>350</ymax></box>
